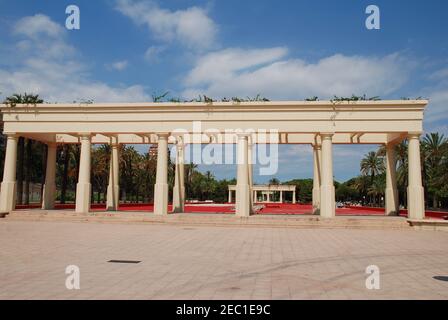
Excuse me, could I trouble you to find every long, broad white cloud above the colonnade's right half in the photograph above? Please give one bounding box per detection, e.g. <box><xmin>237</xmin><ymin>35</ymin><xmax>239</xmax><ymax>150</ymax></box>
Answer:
<box><xmin>183</xmin><ymin>47</ymin><xmax>412</xmax><ymax>99</ymax></box>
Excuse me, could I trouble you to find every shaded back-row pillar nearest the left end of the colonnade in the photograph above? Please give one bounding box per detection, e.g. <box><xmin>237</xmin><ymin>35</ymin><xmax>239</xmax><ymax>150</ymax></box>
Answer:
<box><xmin>42</xmin><ymin>143</ymin><xmax>57</xmax><ymax>210</ymax></box>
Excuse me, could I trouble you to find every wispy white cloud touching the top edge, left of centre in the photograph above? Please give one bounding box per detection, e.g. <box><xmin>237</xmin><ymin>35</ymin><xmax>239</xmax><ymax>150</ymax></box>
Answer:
<box><xmin>116</xmin><ymin>0</ymin><xmax>217</xmax><ymax>49</ymax></box>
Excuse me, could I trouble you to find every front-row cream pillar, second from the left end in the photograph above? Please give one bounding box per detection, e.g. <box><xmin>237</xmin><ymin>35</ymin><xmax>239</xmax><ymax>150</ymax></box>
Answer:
<box><xmin>75</xmin><ymin>133</ymin><xmax>92</xmax><ymax>213</ymax></box>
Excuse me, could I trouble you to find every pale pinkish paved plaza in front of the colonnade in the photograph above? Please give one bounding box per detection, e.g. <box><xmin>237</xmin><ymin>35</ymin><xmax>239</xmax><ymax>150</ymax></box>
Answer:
<box><xmin>0</xmin><ymin>220</ymin><xmax>448</xmax><ymax>299</ymax></box>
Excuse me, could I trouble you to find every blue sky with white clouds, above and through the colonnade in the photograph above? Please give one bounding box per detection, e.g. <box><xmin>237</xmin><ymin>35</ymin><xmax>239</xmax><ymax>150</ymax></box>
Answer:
<box><xmin>0</xmin><ymin>0</ymin><xmax>448</xmax><ymax>182</ymax></box>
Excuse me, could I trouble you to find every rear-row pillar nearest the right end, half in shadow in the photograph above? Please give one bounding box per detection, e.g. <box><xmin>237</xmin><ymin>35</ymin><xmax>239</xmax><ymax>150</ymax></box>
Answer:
<box><xmin>385</xmin><ymin>144</ymin><xmax>399</xmax><ymax>216</ymax></box>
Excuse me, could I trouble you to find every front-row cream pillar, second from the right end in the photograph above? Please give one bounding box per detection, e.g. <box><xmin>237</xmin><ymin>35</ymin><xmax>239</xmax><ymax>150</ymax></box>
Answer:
<box><xmin>320</xmin><ymin>133</ymin><xmax>336</xmax><ymax>218</ymax></box>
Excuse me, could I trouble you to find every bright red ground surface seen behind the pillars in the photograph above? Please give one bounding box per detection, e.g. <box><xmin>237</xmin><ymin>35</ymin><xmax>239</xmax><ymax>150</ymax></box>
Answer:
<box><xmin>16</xmin><ymin>203</ymin><xmax>448</xmax><ymax>219</ymax></box>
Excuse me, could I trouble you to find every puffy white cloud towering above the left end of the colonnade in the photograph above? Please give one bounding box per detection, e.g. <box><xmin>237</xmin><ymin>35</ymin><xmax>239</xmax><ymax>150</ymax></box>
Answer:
<box><xmin>0</xmin><ymin>14</ymin><xmax>150</xmax><ymax>102</ymax></box>
